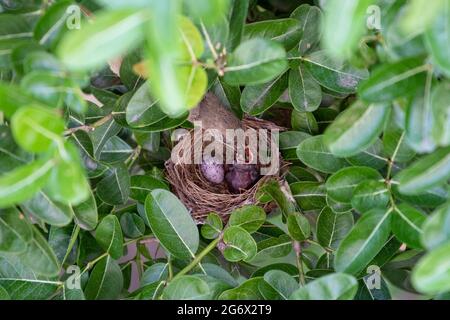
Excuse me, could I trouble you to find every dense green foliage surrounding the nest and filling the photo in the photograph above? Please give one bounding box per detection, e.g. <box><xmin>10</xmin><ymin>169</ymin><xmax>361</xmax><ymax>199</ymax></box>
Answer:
<box><xmin>0</xmin><ymin>0</ymin><xmax>450</xmax><ymax>300</ymax></box>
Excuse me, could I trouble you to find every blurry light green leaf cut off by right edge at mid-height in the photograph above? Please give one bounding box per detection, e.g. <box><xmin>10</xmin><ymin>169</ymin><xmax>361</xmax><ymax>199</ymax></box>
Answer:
<box><xmin>394</xmin><ymin>147</ymin><xmax>450</xmax><ymax>195</ymax></box>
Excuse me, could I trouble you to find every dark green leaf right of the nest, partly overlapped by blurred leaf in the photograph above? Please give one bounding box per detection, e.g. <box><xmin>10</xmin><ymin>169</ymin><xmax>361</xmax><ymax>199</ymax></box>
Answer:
<box><xmin>297</xmin><ymin>136</ymin><xmax>347</xmax><ymax>173</ymax></box>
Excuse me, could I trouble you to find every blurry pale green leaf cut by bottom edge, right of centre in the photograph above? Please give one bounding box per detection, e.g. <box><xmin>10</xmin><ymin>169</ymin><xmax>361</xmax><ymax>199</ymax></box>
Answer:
<box><xmin>290</xmin><ymin>273</ymin><xmax>358</xmax><ymax>300</ymax></box>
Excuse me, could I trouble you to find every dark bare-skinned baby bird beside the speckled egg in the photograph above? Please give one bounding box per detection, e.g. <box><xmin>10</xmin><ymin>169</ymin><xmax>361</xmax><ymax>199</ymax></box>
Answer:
<box><xmin>225</xmin><ymin>164</ymin><xmax>259</xmax><ymax>193</ymax></box>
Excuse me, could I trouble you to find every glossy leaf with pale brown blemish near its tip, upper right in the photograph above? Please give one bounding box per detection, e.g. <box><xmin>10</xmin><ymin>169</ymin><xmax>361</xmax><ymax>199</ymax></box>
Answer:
<box><xmin>302</xmin><ymin>51</ymin><xmax>368</xmax><ymax>94</ymax></box>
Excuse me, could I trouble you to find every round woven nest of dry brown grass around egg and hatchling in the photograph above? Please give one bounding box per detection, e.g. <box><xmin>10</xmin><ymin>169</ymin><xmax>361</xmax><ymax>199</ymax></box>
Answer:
<box><xmin>165</xmin><ymin>117</ymin><xmax>288</xmax><ymax>224</ymax></box>
